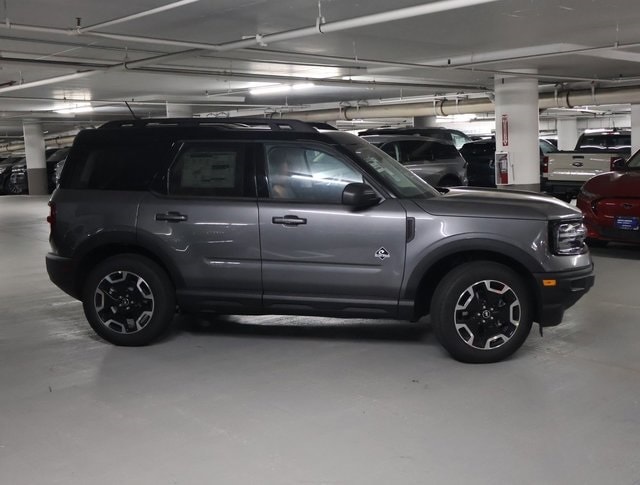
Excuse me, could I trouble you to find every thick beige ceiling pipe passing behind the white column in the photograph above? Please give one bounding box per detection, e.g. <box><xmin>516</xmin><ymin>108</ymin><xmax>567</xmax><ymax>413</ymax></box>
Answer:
<box><xmin>272</xmin><ymin>86</ymin><xmax>640</xmax><ymax>122</ymax></box>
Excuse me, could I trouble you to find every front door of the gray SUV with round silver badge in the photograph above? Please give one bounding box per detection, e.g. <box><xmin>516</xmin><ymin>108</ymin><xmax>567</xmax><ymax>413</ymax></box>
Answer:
<box><xmin>259</xmin><ymin>143</ymin><xmax>407</xmax><ymax>316</ymax></box>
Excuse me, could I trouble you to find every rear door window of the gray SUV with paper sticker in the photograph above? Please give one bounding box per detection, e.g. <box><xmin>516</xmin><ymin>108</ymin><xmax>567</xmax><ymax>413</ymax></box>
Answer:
<box><xmin>169</xmin><ymin>143</ymin><xmax>255</xmax><ymax>197</ymax></box>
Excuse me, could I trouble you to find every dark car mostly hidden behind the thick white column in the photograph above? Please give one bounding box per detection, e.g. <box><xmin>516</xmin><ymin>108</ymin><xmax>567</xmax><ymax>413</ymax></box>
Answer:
<box><xmin>460</xmin><ymin>138</ymin><xmax>556</xmax><ymax>187</ymax></box>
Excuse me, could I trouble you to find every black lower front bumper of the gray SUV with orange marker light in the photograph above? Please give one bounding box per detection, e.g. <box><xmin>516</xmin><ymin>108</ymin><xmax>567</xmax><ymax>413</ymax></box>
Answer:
<box><xmin>534</xmin><ymin>264</ymin><xmax>595</xmax><ymax>327</ymax></box>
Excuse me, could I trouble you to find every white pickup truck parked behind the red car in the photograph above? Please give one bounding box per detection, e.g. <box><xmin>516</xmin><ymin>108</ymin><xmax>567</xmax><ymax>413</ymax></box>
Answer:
<box><xmin>540</xmin><ymin>130</ymin><xmax>631</xmax><ymax>201</ymax></box>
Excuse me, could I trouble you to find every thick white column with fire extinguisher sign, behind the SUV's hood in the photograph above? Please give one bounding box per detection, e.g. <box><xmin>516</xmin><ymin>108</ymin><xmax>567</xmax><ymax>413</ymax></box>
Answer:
<box><xmin>495</xmin><ymin>70</ymin><xmax>540</xmax><ymax>191</ymax></box>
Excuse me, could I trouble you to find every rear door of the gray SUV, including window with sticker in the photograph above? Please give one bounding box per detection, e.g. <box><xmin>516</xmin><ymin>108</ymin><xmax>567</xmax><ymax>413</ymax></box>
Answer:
<box><xmin>138</xmin><ymin>141</ymin><xmax>262</xmax><ymax>309</ymax></box>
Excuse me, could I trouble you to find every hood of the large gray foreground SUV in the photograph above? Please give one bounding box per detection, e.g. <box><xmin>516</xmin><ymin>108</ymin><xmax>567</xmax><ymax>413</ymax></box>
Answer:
<box><xmin>415</xmin><ymin>187</ymin><xmax>582</xmax><ymax>220</ymax></box>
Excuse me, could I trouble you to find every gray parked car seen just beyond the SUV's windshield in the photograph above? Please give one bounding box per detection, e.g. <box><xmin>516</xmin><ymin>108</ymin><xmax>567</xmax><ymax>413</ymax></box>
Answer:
<box><xmin>361</xmin><ymin>135</ymin><xmax>467</xmax><ymax>187</ymax></box>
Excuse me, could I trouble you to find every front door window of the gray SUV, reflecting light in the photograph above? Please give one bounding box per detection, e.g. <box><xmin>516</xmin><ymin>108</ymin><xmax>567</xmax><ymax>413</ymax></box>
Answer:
<box><xmin>266</xmin><ymin>146</ymin><xmax>363</xmax><ymax>204</ymax></box>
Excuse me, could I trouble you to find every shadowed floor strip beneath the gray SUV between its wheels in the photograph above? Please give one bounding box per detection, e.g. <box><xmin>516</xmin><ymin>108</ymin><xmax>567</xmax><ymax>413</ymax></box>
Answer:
<box><xmin>169</xmin><ymin>315</ymin><xmax>431</xmax><ymax>343</ymax></box>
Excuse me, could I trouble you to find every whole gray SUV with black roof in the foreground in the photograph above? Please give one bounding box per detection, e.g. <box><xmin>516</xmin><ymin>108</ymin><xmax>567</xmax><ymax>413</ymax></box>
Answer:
<box><xmin>46</xmin><ymin>119</ymin><xmax>594</xmax><ymax>362</ymax></box>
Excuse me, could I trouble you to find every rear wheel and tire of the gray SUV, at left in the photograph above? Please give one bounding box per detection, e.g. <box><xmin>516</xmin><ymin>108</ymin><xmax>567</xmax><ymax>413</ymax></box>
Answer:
<box><xmin>82</xmin><ymin>254</ymin><xmax>176</xmax><ymax>347</ymax></box>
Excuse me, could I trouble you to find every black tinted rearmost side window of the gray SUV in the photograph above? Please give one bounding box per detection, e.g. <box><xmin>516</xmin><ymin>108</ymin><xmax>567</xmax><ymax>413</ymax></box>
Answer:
<box><xmin>62</xmin><ymin>143</ymin><xmax>166</xmax><ymax>190</ymax></box>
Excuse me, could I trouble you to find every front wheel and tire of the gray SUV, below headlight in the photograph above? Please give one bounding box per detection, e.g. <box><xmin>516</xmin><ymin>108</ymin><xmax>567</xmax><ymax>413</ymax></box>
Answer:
<box><xmin>431</xmin><ymin>261</ymin><xmax>533</xmax><ymax>363</ymax></box>
